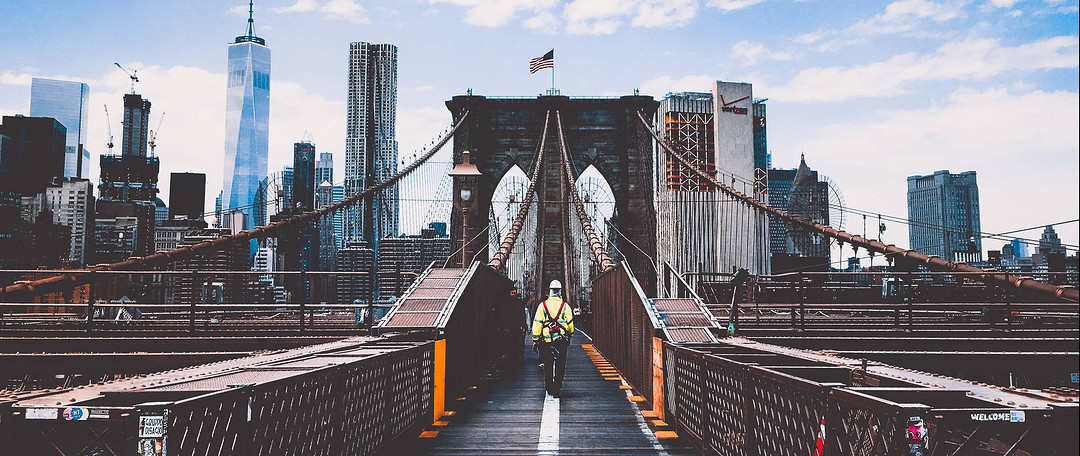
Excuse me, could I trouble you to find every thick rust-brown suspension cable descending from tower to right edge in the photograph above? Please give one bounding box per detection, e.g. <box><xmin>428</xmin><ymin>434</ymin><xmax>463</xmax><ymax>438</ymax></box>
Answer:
<box><xmin>637</xmin><ymin>111</ymin><xmax>1080</xmax><ymax>303</ymax></box>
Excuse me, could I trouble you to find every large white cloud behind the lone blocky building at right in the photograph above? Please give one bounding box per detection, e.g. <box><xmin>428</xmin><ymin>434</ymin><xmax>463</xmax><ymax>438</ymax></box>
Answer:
<box><xmin>799</xmin><ymin>89</ymin><xmax>1080</xmax><ymax>249</ymax></box>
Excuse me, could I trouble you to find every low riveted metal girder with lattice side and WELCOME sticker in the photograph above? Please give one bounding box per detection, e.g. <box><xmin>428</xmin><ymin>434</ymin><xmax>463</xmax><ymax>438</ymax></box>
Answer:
<box><xmin>663</xmin><ymin>343</ymin><xmax>1078</xmax><ymax>456</ymax></box>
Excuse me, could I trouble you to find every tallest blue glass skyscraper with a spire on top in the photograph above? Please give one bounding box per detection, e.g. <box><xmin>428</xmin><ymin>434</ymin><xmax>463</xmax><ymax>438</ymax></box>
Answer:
<box><xmin>221</xmin><ymin>3</ymin><xmax>270</xmax><ymax>230</ymax></box>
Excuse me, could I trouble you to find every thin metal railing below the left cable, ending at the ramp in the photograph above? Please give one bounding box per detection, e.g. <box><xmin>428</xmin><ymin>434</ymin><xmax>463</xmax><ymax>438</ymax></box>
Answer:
<box><xmin>0</xmin><ymin>266</ymin><xmax>417</xmax><ymax>335</ymax></box>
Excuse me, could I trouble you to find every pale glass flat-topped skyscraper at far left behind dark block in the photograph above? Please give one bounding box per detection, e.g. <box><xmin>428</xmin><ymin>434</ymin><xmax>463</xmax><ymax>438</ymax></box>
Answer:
<box><xmin>30</xmin><ymin>78</ymin><xmax>90</xmax><ymax>178</ymax></box>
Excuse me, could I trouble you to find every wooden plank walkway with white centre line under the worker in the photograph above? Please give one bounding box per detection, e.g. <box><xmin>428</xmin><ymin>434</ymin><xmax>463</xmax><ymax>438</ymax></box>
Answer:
<box><xmin>382</xmin><ymin>335</ymin><xmax>694</xmax><ymax>455</ymax></box>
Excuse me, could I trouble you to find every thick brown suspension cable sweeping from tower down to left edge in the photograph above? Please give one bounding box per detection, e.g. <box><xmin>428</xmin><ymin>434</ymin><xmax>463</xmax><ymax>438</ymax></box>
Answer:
<box><xmin>2</xmin><ymin>111</ymin><xmax>469</xmax><ymax>299</ymax></box>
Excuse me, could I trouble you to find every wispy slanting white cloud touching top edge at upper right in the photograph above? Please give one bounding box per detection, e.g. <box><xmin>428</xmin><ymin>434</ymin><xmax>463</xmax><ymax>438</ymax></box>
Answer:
<box><xmin>795</xmin><ymin>0</ymin><xmax>963</xmax><ymax>50</ymax></box>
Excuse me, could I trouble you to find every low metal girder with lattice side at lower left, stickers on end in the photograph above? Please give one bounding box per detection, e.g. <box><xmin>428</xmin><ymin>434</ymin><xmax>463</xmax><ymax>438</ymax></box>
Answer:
<box><xmin>0</xmin><ymin>340</ymin><xmax>436</xmax><ymax>456</ymax></box>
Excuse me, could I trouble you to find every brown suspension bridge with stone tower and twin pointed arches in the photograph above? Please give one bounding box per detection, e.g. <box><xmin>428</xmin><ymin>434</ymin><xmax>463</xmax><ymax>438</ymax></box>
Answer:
<box><xmin>0</xmin><ymin>94</ymin><xmax>1080</xmax><ymax>456</ymax></box>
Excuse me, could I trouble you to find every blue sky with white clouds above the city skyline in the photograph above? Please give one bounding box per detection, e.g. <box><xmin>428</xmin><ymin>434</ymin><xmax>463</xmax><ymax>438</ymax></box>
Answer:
<box><xmin>0</xmin><ymin>0</ymin><xmax>1080</xmax><ymax>256</ymax></box>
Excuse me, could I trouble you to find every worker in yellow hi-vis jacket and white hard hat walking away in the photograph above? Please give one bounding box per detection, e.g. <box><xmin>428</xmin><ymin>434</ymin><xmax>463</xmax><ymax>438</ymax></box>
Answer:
<box><xmin>532</xmin><ymin>280</ymin><xmax>573</xmax><ymax>398</ymax></box>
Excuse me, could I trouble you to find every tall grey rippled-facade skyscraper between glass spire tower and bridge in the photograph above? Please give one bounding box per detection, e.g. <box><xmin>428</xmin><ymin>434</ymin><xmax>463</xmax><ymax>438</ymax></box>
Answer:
<box><xmin>343</xmin><ymin>42</ymin><xmax>399</xmax><ymax>250</ymax></box>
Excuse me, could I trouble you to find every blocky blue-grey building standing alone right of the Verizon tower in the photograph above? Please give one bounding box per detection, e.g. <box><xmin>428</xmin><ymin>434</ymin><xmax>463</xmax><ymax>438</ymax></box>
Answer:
<box><xmin>907</xmin><ymin>171</ymin><xmax>983</xmax><ymax>263</ymax></box>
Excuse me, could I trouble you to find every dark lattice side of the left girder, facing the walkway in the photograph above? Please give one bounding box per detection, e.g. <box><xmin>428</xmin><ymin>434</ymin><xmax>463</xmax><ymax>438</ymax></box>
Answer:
<box><xmin>155</xmin><ymin>344</ymin><xmax>434</xmax><ymax>456</ymax></box>
